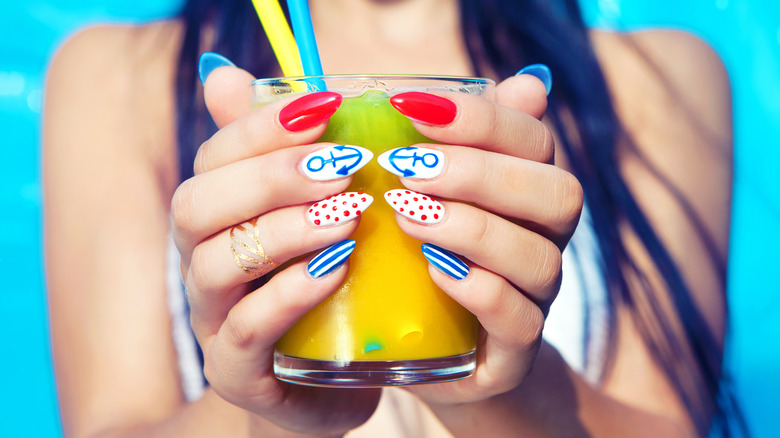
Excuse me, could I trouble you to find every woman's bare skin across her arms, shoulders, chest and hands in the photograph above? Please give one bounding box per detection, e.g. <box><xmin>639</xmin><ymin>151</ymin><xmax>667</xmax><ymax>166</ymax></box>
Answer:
<box><xmin>43</xmin><ymin>0</ymin><xmax>731</xmax><ymax>437</ymax></box>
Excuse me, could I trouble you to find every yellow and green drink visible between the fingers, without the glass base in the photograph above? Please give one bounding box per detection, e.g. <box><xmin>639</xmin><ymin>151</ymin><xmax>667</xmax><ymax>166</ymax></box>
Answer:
<box><xmin>277</xmin><ymin>91</ymin><xmax>477</xmax><ymax>361</ymax></box>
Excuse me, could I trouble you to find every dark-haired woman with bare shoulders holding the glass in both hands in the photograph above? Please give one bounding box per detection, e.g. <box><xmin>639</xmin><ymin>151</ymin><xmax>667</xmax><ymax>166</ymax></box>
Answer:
<box><xmin>44</xmin><ymin>0</ymin><xmax>731</xmax><ymax>437</ymax></box>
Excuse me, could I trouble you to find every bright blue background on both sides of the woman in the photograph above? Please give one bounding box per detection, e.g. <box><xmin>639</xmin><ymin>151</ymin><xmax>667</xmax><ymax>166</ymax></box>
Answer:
<box><xmin>0</xmin><ymin>0</ymin><xmax>780</xmax><ymax>437</ymax></box>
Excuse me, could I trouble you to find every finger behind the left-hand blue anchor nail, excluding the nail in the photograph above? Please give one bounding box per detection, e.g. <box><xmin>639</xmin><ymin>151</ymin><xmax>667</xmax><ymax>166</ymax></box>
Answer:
<box><xmin>171</xmin><ymin>145</ymin><xmax>356</xmax><ymax>260</ymax></box>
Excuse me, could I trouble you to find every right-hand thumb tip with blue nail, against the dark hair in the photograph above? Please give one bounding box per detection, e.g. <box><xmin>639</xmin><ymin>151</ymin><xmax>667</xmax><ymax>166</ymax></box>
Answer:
<box><xmin>496</xmin><ymin>64</ymin><xmax>552</xmax><ymax>119</ymax></box>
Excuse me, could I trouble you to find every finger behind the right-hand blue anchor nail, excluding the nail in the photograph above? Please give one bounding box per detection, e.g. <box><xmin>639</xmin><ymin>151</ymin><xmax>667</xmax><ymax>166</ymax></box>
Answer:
<box><xmin>401</xmin><ymin>145</ymin><xmax>583</xmax><ymax>248</ymax></box>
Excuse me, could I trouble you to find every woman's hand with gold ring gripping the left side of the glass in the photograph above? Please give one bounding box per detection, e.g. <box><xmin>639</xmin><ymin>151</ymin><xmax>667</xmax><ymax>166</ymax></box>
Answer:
<box><xmin>171</xmin><ymin>63</ymin><xmax>380</xmax><ymax>435</ymax></box>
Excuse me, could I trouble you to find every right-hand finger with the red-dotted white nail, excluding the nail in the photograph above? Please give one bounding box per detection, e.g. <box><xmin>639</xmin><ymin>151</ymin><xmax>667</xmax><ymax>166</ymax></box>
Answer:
<box><xmin>396</xmin><ymin>201</ymin><xmax>562</xmax><ymax>312</ymax></box>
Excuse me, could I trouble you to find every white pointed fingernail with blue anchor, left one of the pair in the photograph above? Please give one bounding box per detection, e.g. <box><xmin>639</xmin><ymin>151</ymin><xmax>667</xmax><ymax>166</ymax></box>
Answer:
<box><xmin>301</xmin><ymin>144</ymin><xmax>374</xmax><ymax>181</ymax></box>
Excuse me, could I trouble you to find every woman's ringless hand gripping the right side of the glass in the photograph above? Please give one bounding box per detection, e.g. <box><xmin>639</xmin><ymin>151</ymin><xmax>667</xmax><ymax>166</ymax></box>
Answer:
<box><xmin>396</xmin><ymin>75</ymin><xmax>583</xmax><ymax>404</ymax></box>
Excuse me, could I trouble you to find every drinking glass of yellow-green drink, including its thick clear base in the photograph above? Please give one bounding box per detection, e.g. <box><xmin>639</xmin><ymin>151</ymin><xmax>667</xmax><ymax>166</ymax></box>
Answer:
<box><xmin>250</xmin><ymin>77</ymin><xmax>494</xmax><ymax>386</ymax></box>
